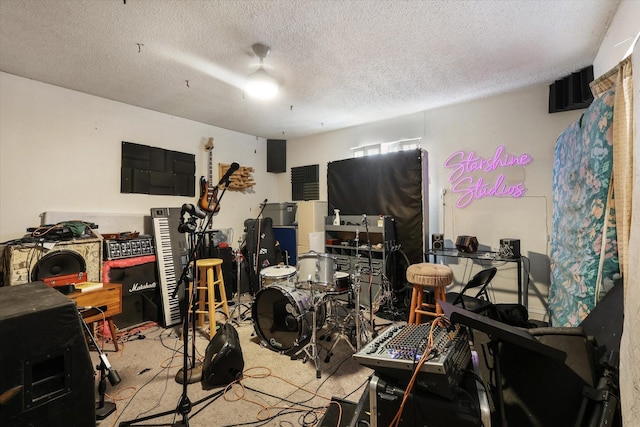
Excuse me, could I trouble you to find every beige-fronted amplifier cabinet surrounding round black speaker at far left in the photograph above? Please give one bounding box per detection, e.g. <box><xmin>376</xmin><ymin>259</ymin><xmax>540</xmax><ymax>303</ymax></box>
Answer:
<box><xmin>0</xmin><ymin>237</ymin><xmax>102</xmax><ymax>286</ymax></box>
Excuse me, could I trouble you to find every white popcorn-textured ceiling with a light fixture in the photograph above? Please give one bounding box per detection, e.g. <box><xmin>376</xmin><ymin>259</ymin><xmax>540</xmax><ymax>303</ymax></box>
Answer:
<box><xmin>0</xmin><ymin>0</ymin><xmax>619</xmax><ymax>139</ymax></box>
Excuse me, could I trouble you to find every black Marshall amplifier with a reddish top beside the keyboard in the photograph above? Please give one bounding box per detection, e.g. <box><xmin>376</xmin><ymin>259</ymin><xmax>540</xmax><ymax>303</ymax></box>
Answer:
<box><xmin>103</xmin><ymin>255</ymin><xmax>161</xmax><ymax>329</ymax></box>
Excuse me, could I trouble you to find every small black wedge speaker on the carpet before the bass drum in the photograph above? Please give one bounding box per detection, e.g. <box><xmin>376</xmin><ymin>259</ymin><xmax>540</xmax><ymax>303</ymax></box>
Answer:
<box><xmin>201</xmin><ymin>323</ymin><xmax>244</xmax><ymax>390</ymax></box>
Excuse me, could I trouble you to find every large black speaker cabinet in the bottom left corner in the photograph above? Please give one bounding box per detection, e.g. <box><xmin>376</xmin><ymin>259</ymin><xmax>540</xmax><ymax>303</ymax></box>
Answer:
<box><xmin>0</xmin><ymin>282</ymin><xmax>96</xmax><ymax>427</ymax></box>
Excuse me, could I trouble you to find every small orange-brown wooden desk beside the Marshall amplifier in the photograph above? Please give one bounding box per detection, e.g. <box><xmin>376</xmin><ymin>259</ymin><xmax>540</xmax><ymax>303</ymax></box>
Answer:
<box><xmin>67</xmin><ymin>283</ymin><xmax>122</xmax><ymax>351</ymax></box>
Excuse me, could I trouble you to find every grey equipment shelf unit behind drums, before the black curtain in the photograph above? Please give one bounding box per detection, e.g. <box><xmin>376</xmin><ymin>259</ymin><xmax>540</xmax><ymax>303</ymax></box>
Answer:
<box><xmin>325</xmin><ymin>215</ymin><xmax>396</xmax><ymax>307</ymax></box>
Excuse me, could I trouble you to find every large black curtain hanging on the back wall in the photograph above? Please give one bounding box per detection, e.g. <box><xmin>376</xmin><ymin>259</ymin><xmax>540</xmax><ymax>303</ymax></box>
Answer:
<box><xmin>327</xmin><ymin>150</ymin><xmax>427</xmax><ymax>263</ymax></box>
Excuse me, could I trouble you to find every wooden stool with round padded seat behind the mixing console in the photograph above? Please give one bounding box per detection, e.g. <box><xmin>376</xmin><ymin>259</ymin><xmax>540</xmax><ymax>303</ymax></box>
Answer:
<box><xmin>407</xmin><ymin>262</ymin><xmax>453</xmax><ymax>325</ymax></box>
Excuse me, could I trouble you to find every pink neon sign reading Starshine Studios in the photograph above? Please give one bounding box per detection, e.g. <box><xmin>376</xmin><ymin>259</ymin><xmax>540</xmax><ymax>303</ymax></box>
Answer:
<box><xmin>444</xmin><ymin>145</ymin><xmax>533</xmax><ymax>208</ymax></box>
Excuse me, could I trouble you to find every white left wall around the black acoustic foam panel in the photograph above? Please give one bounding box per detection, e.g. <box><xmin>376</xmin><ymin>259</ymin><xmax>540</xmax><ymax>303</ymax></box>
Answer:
<box><xmin>0</xmin><ymin>73</ymin><xmax>277</xmax><ymax>247</ymax></box>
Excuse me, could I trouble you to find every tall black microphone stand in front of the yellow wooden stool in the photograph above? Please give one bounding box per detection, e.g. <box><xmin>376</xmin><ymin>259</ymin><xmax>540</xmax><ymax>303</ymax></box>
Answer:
<box><xmin>119</xmin><ymin>174</ymin><xmax>231</xmax><ymax>427</ymax></box>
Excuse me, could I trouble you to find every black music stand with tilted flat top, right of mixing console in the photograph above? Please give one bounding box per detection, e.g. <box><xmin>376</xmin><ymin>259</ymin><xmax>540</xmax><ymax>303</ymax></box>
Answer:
<box><xmin>439</xmin><ymin>301</ymin><xmax>567</xmax><ymax>427</ymax></box>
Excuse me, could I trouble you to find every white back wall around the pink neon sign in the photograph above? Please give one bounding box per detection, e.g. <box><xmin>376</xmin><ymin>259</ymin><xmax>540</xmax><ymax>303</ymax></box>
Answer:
<box><xmin>278</xmin><ymin>85</ymin><xmax>582</xmax><ymax>318</ymax></box>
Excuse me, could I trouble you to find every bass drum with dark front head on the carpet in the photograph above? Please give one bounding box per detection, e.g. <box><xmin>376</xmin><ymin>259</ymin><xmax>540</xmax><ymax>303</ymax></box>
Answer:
<box><xmin>251</xmin><ymin>284</ymin><xmax>326</xmax><ymax>351</ymax></box>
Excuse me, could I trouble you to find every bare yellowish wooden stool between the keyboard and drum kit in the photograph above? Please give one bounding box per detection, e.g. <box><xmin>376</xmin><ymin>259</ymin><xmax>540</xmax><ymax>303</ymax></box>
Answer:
<box><xmin>189</xmin><ymin>258</ymin><xmax>231</xmax><ymax>339</ymax></box>
